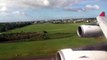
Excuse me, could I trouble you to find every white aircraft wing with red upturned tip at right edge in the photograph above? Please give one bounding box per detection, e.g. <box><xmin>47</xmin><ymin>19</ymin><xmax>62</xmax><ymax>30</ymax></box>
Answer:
<box><xmin>97</xmin><ymin>12</ymin><xmax>107</xmax><ymax>39</ymax></box>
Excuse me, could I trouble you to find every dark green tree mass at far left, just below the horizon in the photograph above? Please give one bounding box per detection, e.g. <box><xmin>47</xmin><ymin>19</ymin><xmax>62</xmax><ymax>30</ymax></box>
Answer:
<box><xmin>0</xmin><ymin>22</ymin><xmax>33</xmax><ymax>32</ymax></box>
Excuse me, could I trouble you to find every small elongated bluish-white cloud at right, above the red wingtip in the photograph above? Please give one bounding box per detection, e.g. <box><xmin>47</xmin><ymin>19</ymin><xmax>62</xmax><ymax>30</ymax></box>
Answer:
<box><xmin>64</xmin><ymin>5</ymin><xmax>100</xmax><ymax>12</ymax></box>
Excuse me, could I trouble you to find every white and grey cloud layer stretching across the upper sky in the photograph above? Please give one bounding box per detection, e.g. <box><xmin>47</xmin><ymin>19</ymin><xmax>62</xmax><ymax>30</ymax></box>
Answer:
<box><xmin>0</xmin><ymin>0</ymin><xmax>100</xmax><ymax>15</ymax></box>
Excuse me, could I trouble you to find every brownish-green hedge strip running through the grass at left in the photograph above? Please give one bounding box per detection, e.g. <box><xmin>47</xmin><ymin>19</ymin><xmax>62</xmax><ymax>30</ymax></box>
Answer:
<box><xmin>0</xmin><ymin>32</ymin><xmax>47</xmax><ymax>42</ymax></box>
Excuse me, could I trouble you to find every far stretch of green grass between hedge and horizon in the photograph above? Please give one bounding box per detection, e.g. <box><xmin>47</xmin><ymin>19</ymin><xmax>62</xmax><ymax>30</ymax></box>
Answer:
<box><xmin>6</xmin><ymin>24</ymin><xmax>79</xmax><ymax>33</ymax></box>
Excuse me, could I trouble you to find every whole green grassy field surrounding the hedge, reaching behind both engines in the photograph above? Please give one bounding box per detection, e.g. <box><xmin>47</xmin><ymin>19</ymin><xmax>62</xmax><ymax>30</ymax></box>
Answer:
<box><xmin>0</xmin><ymin>23</ymin><xmax>105</xmax><ymax>59</ymax></box>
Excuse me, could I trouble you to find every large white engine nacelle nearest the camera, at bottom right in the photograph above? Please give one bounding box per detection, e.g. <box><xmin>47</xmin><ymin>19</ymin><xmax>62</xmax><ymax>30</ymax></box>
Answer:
<box><xmin>55</xmin><ymin>49</ymin><xmax>107</xmax><ymax>60</ymax></box>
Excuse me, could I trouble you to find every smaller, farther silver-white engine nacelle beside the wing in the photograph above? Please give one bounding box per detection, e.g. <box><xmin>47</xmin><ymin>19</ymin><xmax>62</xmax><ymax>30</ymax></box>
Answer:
<box><xmin>77</xmin><ymin>25</ymin><xmax>103</xmax><ymax>37</ymax></box>
